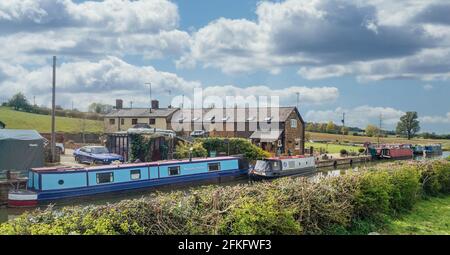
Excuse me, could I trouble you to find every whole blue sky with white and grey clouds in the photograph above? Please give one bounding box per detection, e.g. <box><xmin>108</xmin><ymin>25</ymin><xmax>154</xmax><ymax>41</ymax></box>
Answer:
<box><xmin>0</xmin><ymin>0</ymin><xmax>450</xmax><ymax>133</ymax></box>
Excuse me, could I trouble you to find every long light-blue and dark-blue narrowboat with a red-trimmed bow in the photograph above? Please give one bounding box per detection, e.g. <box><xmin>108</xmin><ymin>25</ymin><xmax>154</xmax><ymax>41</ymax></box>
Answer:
<box><xmin>8</xmin><ymin>156</ymin><xmax>248</xmax><ymax>207</ymax></box>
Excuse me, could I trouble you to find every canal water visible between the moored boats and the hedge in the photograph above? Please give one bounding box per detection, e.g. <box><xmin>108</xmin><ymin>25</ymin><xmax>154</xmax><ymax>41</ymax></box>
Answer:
<box><xmin>0</xmin><ymin>151</ymin><xmax>450</xmax><ymax>223</ymax></box>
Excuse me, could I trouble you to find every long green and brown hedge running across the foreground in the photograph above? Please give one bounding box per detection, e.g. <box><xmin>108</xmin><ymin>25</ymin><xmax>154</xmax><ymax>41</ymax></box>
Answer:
<box><xmin>0</xmin><ymin>160</ymin><xmax>450</xmax><ymax>234</ymax></box>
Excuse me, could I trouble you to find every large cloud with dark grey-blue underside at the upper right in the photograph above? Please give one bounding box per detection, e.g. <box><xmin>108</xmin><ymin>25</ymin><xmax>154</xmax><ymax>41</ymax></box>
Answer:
<box><xmin>177</xmin><ymin>0</ymin><xmax>450</xmax><ymax>81</ymax></box>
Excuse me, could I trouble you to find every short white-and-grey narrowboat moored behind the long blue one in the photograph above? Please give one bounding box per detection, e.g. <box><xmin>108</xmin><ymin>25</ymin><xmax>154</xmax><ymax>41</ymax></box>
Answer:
<box><xmin>249</xmin><ymin>156</ymin><xmax>316</xmax><ymax>180</ymax></box>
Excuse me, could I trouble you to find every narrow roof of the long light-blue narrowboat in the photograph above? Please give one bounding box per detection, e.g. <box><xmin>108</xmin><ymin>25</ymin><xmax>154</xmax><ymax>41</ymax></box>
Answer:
<box><xmin>31</xmin><ymin>156</ymin><xmax>239</xmax><ymax>172</ymax></box>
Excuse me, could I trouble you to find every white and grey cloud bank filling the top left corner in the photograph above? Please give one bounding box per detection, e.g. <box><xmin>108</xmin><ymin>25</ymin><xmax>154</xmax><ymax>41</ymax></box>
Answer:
<box><xmin>0</xmin><ymin>0</ymin><xmax>190</xmax><ymax>63</ymax></box>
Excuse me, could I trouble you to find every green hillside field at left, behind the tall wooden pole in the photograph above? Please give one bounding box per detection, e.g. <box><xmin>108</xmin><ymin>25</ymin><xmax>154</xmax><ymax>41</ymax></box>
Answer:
<box><xmin>0</xmin><ymin>107</ymin><xmax>103</xmax><ymax>133</ymax></box>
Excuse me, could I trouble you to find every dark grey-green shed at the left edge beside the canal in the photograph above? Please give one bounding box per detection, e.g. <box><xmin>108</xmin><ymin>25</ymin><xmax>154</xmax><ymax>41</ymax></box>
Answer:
<box><xmin>0</xmin><ymin>129</ymin><xmax>45</xmax><ymax>172</ymax></box>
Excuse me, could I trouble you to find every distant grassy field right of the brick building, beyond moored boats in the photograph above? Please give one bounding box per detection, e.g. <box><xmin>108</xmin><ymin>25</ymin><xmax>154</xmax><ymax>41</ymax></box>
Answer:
<box><xmin>306</xmin><ymin>132</ymin><xmax>450</xmax><ymax>150</ymax></box>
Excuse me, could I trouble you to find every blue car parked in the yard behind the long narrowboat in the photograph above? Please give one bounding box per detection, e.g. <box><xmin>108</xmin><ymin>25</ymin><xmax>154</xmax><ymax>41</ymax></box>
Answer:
<box><xmin>73</xmin><ymin>146</ymin><xmax>124</xmax><ymax>165</ymax></box>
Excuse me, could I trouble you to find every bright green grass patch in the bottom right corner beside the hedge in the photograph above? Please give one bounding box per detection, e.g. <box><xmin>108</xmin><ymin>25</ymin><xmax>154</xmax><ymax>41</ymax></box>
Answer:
<box><xmin>382</xmin><ymin>196</ymin><xmax>450</xmax><ymax>235</ymax></box>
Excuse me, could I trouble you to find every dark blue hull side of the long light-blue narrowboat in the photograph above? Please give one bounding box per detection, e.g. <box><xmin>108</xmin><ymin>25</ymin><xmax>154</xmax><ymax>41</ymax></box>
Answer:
<box><xmin>37</xmin><ymin>169</ymin><xmax>248</xmax><ymax>202</ymax></box>
